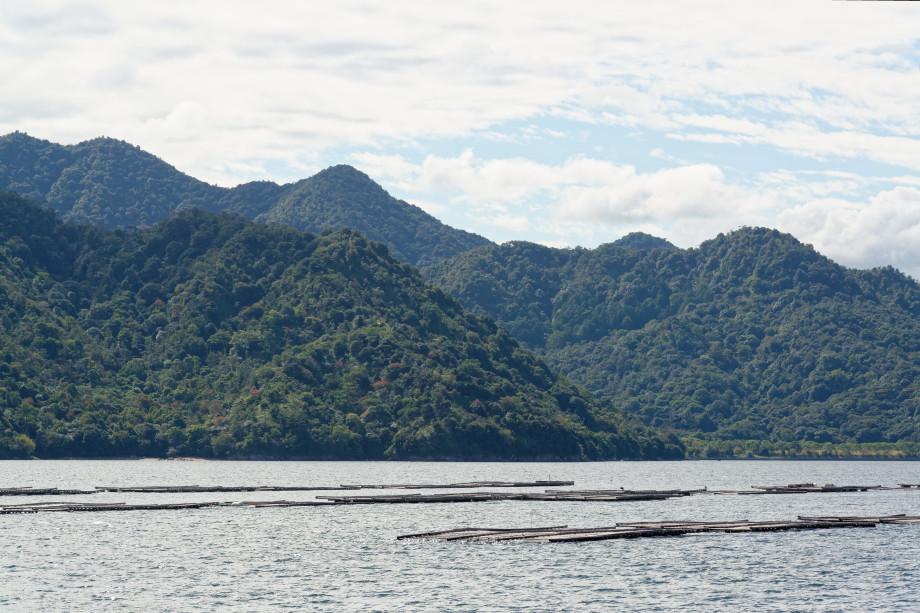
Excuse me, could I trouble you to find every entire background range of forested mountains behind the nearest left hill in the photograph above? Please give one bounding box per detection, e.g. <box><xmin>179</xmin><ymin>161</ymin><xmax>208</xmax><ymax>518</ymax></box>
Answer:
<box><xmin>0</xmin><ymin>133</ymin><xmax>920</xmax><ymax>455</ymax></box>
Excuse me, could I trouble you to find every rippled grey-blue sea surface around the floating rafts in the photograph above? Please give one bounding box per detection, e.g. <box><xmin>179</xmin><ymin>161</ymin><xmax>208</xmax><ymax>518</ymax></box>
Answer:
<box><xmin>0</xmin><ymin>461</ymin><xmax>920</xmax><ymax>612</ymax></box>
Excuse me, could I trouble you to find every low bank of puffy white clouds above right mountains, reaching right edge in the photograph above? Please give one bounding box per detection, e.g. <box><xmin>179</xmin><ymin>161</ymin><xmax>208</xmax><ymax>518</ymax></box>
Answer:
<box><xmin>357</xmin><ymin>150</ymin><xmax>920</xmax><ymax>278</ymax></box>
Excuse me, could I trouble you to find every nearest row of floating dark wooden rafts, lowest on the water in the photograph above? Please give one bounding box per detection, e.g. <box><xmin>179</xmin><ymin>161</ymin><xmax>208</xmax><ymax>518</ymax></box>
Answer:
<box><xmin>396</xmin><ymin>515</ymin><xmax>920</xmax><ymax>543</ymax></box>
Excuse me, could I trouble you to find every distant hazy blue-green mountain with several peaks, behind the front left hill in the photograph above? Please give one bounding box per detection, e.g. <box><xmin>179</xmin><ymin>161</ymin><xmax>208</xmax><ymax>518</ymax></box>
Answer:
<box><xmin>0</xmin><ymin>132</ymin><xmax>489</xmax><ymax>266</ymax></box>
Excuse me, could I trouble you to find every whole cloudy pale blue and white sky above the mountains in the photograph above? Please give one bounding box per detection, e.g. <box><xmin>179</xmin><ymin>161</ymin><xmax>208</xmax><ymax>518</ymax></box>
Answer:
<box><xmin>0</xmin><ymin>0</ymin><xmax>920</xmax><ymax>279</ymax></box>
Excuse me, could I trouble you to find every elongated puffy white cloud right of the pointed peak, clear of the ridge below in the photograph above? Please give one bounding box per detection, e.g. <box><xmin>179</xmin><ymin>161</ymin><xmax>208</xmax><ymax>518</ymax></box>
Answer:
<box><xmin>355</xmin><ymin>149</ymin><xmax>769</xmax><ymax>224</ymax></box>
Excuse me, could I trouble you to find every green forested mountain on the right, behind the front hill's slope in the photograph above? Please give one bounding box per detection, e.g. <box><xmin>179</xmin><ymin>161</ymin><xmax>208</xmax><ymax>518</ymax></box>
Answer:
<box><xmin>426</xmin><ymin>228</ymin><xmax>920</xmax><ymax>454</ymax></box>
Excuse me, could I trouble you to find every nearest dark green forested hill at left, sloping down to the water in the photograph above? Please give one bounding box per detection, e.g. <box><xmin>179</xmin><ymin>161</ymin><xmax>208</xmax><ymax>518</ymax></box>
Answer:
<box><xmin>0</xmin><ymin>193</ymin><xmax>681</xmax><ymax>459</ymax></box>
